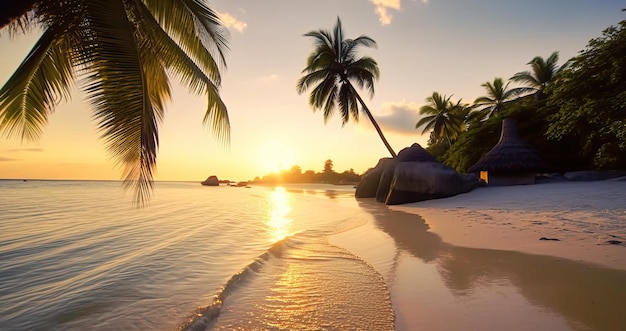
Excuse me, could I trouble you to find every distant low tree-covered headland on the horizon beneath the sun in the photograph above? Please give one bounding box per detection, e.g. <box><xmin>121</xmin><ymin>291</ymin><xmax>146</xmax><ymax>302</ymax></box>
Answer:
<box><xmin>252</xmin><ymin>159</ymin><xmax>361</xmax><ymax>185</ymax></box>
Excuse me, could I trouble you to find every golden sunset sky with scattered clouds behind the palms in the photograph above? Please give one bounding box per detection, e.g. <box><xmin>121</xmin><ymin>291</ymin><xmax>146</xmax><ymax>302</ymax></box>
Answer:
<box><xmin>0</xmin><ymin>0</ymin><xmax>626</xmax><ymax>181</ymax></box>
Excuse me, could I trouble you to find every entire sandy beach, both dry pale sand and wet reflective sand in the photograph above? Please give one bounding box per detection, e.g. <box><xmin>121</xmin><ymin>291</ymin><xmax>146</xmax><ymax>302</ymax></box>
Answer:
<box><xmin>330</xmin><ymin>181</ymin><xmax>626</xmax><ymax>330</ymax></box>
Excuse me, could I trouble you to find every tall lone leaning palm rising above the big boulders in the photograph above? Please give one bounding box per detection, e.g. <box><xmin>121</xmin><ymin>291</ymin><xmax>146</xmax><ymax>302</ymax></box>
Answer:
<box><xmin>296</xmin><ymin>17</ymin><xmax>396</xmax><ymax>157</ymax></box>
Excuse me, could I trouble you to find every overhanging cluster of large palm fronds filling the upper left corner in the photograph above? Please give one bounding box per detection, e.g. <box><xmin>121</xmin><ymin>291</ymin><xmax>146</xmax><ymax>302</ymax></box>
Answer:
<box><xmin>0</xmin><ymin>0</ymin><xmax>230</xmax><ymax>205</ymax></box>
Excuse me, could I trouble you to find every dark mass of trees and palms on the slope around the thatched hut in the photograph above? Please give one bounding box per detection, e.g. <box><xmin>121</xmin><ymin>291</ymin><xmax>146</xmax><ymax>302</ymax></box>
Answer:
<box><xmin>417</xmin><ymin>11</ymin><xmax>626</xmax><ymax>172</ymax></box>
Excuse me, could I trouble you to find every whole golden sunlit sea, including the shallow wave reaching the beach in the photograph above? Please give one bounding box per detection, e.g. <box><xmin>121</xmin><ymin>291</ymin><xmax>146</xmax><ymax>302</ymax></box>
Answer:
<box><xmin>0</xmin><ymin>181</ymin><xmax>393</xmax><ymax>330</ymax></box>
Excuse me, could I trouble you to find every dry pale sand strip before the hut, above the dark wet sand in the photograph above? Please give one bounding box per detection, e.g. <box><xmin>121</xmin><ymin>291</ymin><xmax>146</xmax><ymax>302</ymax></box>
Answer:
<box><xmin>388</xmin><ymin>181</ymin><xmax>626</xmax><ymax>270</ymax></box>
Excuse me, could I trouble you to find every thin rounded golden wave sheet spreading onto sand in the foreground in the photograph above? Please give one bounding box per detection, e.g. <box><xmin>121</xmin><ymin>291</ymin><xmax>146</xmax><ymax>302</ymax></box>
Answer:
<box><xmin>178</xmin><ymin>230</ymin><xmax>394</xmax><ymax>331</ymax></box>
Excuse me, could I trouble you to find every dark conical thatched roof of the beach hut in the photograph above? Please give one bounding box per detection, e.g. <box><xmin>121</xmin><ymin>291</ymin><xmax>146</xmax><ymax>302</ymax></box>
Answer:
<box><xmin>468</xmin><ymin>118</ymin><xmax>545</xmax><ymax>173</ymax></box>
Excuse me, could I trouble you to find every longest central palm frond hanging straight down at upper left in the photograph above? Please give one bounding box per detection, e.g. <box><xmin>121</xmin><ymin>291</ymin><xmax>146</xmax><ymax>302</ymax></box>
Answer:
<box><xmin>84</xmin><ymin>0</ymin><xmax>154</xmax><ymax>206</ymax></box>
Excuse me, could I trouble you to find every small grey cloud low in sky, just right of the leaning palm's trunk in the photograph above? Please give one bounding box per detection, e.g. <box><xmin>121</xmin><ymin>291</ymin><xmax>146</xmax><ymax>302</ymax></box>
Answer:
<box><xmin>374</xmin><ymin>101</ymin><xmax>420</xmax><ymax>135</ymax></box>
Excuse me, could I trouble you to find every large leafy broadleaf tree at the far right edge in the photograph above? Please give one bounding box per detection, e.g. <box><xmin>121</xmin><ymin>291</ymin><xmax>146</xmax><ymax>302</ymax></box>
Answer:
<box><xmin>546</xmin><ymin>21</ymin><xmax>626</xmax><ymax>168</ymax></box>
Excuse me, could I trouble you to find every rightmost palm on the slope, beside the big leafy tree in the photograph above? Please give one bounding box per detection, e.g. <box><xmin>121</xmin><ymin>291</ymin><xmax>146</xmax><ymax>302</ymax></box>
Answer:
<box><xmin>511</xmin><ymin>52</ymin><xmax>568</xmax><ymax>99</ymax></box>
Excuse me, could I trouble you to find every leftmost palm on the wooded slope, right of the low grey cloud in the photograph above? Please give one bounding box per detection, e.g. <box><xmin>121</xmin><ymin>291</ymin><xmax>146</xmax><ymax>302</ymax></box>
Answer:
<box><xmin>415</xmin><ymin>92</ymin><xmax>469</xmax><ymax>146</ymax></box>
